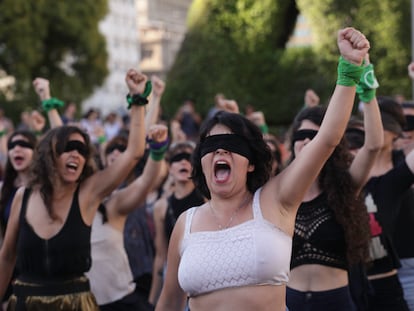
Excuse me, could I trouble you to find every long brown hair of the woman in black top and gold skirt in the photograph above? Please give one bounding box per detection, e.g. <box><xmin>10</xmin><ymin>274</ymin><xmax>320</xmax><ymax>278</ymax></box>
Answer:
<box><xmin>29</xmin><ymin>125</ymin><xmax>96</xmax><ymax>217</ymax></box>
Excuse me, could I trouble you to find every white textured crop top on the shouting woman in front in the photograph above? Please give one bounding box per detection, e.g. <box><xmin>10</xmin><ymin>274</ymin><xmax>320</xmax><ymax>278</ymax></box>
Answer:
<box><xmin>178</xmin><ymin>189</ymin><xmax>292</xmax><ymax>296</ymax></box>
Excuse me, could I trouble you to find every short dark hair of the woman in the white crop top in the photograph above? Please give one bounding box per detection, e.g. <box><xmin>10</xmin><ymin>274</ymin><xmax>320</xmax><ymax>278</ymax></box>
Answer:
<box><xmin>191</xmin><ymin>111</ymin><xmax>272</xmax><ymax>199</ymax></box>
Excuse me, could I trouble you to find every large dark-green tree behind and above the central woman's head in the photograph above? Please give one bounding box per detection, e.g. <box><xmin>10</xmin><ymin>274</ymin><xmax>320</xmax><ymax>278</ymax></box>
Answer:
<box><xmin>163</xmin><ymin>0</ymin><xmax>298</xmax><ymax>125</ymax></box>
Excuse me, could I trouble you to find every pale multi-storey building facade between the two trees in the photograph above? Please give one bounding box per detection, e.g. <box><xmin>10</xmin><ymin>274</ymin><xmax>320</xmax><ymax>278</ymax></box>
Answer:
<box><xmin>82</xmin><ymin>0</ymin><xmax>192</xmax><ymax>116</ymax></box>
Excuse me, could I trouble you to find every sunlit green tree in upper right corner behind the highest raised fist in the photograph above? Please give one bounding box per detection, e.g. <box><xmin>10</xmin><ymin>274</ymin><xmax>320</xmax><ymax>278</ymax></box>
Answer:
<box><xmin>297</xmin><ymin>0</ymin><xmax>411</xmax><ymax>98</ymax></box>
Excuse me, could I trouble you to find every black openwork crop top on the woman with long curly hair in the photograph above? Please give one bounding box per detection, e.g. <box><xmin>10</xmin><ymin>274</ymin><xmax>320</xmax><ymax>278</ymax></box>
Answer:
<box><xmin>291</xmin><ymin>193</ymin><xmax>348</xmax><ymax>270</ymax></box>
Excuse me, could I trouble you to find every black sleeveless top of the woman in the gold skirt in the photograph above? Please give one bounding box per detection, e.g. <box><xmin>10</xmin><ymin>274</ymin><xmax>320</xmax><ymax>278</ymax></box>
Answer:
<box><xmin>17</xmin><ymin>187</ymin><xmax>91</xmax><ymax>280</ymax></box>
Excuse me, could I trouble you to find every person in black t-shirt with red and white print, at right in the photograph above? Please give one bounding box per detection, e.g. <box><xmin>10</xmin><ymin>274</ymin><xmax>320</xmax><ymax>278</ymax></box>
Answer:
<box><xmin>364</xmin><ymin>96</ymin><xmax>414</xmax><ymax>311</ymax></box>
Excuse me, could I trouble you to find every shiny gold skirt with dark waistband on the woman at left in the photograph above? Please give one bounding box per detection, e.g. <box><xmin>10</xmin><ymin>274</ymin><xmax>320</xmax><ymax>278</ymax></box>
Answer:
<box><xmin>7</xmin><ymin>277</ymin><xmax>99</xmax><ymax>311</ymax></box>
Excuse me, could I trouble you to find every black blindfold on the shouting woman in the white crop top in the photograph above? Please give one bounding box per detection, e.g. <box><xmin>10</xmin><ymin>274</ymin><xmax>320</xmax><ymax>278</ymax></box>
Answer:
<box><xmin>200</xmin><ymin>134</ymin><xmax>253</xmax><ymax>162</ymax></box>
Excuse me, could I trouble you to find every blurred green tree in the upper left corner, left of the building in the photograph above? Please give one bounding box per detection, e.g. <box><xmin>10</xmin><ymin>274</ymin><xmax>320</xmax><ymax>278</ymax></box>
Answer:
<box><xmin>0</xmin><ymin>0</ymin><xmax>107</xmax><ymax>119</ymax></box>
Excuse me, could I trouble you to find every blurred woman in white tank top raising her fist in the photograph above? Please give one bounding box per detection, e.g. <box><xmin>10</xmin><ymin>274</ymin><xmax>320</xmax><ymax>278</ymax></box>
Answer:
<box><xmin>86</xmin><ymin>125</ymin><xmax>168</xmax><ymax>311</ymax></box>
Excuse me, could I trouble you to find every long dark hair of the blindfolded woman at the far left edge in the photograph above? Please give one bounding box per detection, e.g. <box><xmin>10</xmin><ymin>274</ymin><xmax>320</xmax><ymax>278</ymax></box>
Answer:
<box><xmin>0</xmin><ymin>130</ymin><xmax>37</xmax><ymax>234</ymax></box>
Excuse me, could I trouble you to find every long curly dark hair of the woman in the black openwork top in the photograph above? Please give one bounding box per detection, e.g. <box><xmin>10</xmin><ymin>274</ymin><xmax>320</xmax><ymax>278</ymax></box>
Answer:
<box><xmin>290</xmin><ymin>106</ymin><xmax>371</xmax><ymax>264</ymax></box>
